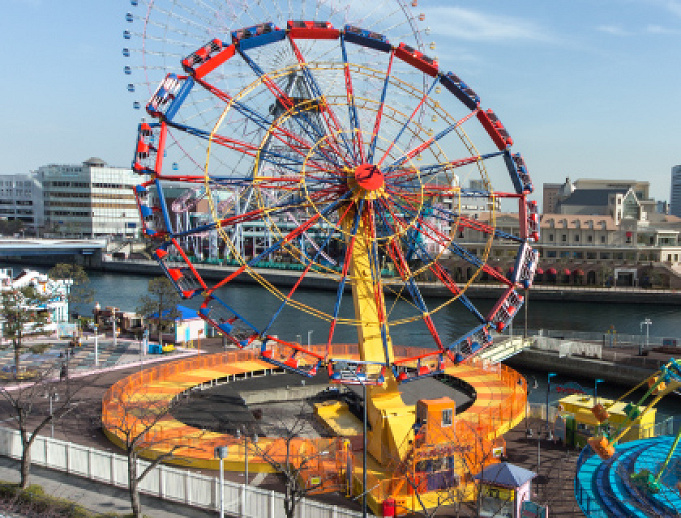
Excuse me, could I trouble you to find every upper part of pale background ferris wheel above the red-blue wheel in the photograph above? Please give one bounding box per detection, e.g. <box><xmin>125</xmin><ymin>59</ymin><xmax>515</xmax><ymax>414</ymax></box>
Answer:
<box><xmin>123</xmin><ymin>0</ymin><xmax>435</xmax><ymax>109</ymax></box>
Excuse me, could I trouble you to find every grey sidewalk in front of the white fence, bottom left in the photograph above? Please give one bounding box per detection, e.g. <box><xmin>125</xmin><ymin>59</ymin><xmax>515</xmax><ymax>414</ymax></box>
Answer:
<box><xmin>0</xmin><ymin>457</ymin><xmax>218</xmax><ymax>518</ymax></box>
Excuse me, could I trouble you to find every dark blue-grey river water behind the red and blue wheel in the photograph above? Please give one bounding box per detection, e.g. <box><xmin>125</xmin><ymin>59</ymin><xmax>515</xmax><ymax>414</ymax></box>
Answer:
<box><xmin>5</xmin><ymin>264</ymin><xmax>681</xmax><ymax>426</ymax></box>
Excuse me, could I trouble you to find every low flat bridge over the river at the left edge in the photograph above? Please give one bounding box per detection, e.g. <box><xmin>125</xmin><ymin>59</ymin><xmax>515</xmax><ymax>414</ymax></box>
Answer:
<box><xmin>0</xmin><ymin>237</ymin><xmax>107</xmax><ymax>258</ymax></box>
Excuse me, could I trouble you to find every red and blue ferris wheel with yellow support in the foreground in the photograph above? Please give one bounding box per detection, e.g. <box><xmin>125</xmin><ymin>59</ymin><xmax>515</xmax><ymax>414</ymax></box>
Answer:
<box><xmin>133</xmin><ymin>16</ymin><xmax>539</xmax><ymax>386</ymax></box>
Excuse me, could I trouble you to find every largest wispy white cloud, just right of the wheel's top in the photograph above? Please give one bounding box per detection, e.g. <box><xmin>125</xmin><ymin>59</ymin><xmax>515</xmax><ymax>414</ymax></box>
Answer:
<box><xmin>423</xmin><ymin>7</ymin><xmax>552</xmax><ymax>41</ymax></box>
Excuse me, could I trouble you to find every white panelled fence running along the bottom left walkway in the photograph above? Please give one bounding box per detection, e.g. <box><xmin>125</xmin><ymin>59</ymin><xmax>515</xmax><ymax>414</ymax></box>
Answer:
<box><xmin>0</xmin><ymin>428</ymin><xmax>361</xmax><ymax>518</ymax></box>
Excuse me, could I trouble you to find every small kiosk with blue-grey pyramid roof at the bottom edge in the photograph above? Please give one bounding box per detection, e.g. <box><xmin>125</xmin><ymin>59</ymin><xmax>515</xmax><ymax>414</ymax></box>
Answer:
<box><xmin>473</xmin><ymin>462</ymin><xmax>548</xmax><ymax>518</ymax></box>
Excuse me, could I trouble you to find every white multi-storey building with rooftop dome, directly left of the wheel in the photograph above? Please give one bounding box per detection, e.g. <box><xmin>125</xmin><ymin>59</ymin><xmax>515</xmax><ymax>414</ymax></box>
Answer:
<box><xmin>35</xmin><ymin>158</ymin><xmax>140</xmax><ymax>237</ymax></box>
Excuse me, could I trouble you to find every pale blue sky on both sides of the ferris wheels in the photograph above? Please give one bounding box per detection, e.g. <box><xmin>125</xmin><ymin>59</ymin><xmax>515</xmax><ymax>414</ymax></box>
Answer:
<box><xmin>0</xmin><ymin>0</ymin><xmax>681</xmax><ymax>206</ymax></box>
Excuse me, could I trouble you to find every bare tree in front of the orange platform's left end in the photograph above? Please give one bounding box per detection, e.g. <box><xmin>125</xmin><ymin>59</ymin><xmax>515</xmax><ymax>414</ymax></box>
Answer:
<box><xmin>102</xmin><ymin>383</ymin><xmax>203</xmax><ymax>518</ymax></box>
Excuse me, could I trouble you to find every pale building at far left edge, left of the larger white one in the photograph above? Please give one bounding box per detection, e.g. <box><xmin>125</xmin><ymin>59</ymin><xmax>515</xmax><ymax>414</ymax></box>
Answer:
<box><xmin>0</xmin><ymin>174</ymin><xmax>44</xmax><ymax>234</ymax></box>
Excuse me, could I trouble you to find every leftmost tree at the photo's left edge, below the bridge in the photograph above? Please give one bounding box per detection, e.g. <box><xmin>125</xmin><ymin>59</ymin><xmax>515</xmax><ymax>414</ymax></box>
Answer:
<box><xmin>0</xmin><ymin>285</ymin><xmax>50</xmax><ymax>379</ymax></box>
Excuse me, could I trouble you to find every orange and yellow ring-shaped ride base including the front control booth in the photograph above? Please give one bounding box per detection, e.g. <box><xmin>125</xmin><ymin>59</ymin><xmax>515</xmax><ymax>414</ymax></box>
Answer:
<box><xmin>102</xmin><ymin>345</ymin><xmax>526</xmax><ymax>514</ymax></box>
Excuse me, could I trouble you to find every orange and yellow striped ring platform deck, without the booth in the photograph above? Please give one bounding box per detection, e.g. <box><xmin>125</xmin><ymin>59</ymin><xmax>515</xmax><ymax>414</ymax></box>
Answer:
<box><xmin>102</xmin><ymin>344</ymin><xmax>526</xmax><ymax>472</ymax></box>
